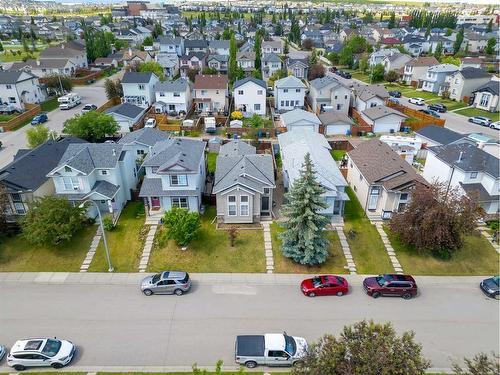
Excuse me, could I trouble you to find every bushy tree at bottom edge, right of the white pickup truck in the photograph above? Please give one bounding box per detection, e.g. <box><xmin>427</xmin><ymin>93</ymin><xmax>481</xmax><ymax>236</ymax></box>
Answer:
<box><xmin>292</xmin><ymin>321</ymin><xmax>430</xmax><ymax>375</ymax></box>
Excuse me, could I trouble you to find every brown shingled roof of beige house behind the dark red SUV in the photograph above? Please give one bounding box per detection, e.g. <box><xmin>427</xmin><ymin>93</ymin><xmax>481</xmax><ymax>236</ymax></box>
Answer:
<box><xmin>347</xmin><ymin>139</ymin><xmax>426</xmax><ymax>191</ymax></box>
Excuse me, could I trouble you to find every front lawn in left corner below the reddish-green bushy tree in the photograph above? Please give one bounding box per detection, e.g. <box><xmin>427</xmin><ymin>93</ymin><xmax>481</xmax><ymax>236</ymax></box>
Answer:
<box><xmin>0</xmin><ymin>225</ymin><xmax>97</xmax><ymax>272</ymax></box>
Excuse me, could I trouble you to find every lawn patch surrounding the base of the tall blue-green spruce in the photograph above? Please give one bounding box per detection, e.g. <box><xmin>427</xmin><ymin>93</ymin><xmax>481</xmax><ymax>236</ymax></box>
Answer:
<box><xmin>271</xmin><ymin>222</ymin><xmax>347</xmax><ymax>274</ymax></box>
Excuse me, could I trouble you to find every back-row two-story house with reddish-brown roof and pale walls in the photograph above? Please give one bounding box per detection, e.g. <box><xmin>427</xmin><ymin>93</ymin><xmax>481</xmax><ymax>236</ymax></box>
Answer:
<box><xmin>194</xmin><ymin>74</ymin><xmax>229</xmax><ymax>112</ymax></box>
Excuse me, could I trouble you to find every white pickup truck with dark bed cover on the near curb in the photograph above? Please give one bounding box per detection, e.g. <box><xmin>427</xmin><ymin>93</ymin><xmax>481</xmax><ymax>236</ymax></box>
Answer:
<box><xmin>234</xmin><ymin>332</ymin><xmax>307</xmax><ymax>368</ymax></box>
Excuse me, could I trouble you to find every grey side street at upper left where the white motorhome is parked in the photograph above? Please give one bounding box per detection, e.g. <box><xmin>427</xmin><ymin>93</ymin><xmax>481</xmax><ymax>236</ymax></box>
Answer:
<box><xmin>0</xmin><ymin>82</ymin><xmax>109</xmax><ymax>168</ymax></box>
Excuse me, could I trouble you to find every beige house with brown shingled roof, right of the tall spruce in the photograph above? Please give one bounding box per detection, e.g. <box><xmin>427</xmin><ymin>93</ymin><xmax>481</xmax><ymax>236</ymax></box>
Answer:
<box><xmin>347</xmin><ymin>139</ymin><xmax>426</xmax><ymax>220</ymax></box>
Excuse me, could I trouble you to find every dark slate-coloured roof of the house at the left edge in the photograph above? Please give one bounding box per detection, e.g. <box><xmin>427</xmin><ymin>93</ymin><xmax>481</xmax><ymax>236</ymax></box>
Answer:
<box><xmin>0</xmin><ymin>137</ymin><xmax>86</xmax><ymax>192</ymax></box>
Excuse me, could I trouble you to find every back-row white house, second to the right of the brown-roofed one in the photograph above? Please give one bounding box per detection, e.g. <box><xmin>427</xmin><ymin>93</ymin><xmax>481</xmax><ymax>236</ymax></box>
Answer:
<box><xmin>274</xmin><ymin>76</ymin><xmax>306</xmax><ymax>112</ymax></box>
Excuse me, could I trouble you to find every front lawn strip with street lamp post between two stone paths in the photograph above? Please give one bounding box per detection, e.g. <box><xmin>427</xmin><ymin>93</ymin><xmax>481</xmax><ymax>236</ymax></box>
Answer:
<box><xmin>89</xmin><ymin>202</ymin><xmax>149</xmax><ymax>272</ymax></box>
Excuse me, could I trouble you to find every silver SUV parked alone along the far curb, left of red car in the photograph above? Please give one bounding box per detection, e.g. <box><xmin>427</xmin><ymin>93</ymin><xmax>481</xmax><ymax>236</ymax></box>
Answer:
<box><xmin>141</xmin><ymin>271</ymin><xmax>191</xmax><ymax>296</ymax></box>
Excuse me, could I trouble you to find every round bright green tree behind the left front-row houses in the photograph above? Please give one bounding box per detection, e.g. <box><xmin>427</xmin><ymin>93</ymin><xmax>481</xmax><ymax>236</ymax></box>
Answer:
<box><xmin>63</xmin><ymin>111</ymin><xmax>120</xmax><ymax>142</ymax></box>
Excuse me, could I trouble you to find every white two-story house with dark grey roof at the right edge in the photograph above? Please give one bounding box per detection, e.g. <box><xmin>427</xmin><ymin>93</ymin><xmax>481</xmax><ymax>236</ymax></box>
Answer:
<box><xmin>423</xmin><ymin>142</ymin><xmax>500</xmax><ymax>218</ymax></box>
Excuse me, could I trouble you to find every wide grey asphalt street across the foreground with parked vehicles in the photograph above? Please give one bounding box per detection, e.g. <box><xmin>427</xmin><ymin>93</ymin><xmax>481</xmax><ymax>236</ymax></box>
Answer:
<box><xmin>0</xmin><ymin>277</ymin><xmax>499</xmax><ymax>372</ymax></box>
